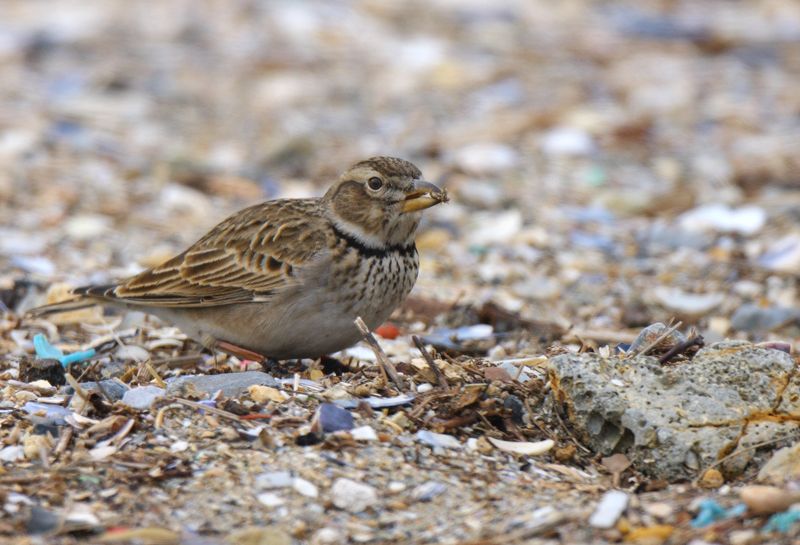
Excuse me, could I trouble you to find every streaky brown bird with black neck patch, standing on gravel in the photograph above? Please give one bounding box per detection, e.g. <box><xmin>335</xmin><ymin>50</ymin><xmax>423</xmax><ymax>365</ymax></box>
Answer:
<box><xmin>29</xmin><ymin>156</ymin><xmax>449</xmax><ymax>361</ymax></box>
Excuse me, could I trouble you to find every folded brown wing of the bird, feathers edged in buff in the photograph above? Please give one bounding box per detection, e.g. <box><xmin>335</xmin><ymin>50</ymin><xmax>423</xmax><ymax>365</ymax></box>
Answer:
<box><xmin>85</xmin><ymin>199</ymin><xmax>326</xmax><ymax>307</ymax></box>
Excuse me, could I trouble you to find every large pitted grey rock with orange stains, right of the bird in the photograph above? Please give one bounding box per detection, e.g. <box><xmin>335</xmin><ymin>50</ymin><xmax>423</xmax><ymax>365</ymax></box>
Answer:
<box><xmin>549</xmin><ymin>341</ymin><xmax>800</xmax><ymax>480</ymax></box>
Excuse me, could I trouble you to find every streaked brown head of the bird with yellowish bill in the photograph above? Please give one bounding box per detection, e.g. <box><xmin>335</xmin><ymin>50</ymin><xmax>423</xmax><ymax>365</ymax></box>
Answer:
<box><xmin>323</xmin><ymin>157</ymin><xmax>448</xmax><ymax>248</ymax></box>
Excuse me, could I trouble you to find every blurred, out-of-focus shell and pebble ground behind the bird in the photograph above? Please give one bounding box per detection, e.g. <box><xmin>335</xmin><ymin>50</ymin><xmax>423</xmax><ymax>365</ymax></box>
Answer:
<box><xmin>0</xmin><ymin>0</ymin><xmax>800</xmax><ymax>344</ymax></box>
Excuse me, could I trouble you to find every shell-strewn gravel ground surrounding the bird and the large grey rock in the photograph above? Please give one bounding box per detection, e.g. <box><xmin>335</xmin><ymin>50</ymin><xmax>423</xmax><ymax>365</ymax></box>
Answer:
<box><xmin>0</xmin><ymin>0</ymin><xmax>800</xmax><ymax>545</ymax></box>
